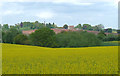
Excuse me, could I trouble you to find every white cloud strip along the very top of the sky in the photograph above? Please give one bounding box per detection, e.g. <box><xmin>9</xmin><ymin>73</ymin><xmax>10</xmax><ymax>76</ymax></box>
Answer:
<box><xmin>1</xmin><ymin>0</ymin><xmax>120</xmax><ymax>7</ymax></box>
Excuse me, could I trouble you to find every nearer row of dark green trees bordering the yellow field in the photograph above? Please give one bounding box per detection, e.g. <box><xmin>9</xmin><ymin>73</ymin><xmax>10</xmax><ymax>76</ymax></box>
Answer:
<box><xmin>2</xmin><ymin>27</ymin><xmax>120</xmax><ymax>48</ymax></box>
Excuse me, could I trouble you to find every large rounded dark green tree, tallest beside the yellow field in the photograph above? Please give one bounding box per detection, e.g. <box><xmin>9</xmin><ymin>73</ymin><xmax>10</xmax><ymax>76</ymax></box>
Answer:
<box><xmin>30</xmin><ymin>28</ymin><xmax>56</xmax><ymax>47</ymax></box>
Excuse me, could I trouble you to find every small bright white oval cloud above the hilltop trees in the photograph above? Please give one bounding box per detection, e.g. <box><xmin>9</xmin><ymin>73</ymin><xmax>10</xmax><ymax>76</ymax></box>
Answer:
<box><xmin>36</xmin><ymin>11</ymin><xmax>54</xmax><ymax>19</ymax></box>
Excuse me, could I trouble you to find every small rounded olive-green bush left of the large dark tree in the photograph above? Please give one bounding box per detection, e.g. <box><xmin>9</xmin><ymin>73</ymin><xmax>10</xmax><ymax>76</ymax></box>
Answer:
<box><xmin>14</xmin><ymin>34</ymin><xmax>29</xmax><ymax>44</ymax></box>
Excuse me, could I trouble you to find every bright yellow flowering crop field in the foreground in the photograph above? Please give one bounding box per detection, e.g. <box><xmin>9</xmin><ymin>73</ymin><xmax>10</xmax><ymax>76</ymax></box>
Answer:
<box><xmin>2</xmin><ymin>44</ymin><xmax>118</xmax><ymax>74</ymax></box>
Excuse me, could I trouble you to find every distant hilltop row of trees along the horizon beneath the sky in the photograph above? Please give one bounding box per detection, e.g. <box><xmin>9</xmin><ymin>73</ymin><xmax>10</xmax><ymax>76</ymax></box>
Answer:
<box><xmin>2</xmin><ymin>21</ymin><xmax>120</xmax><ymax>33</ymax></box>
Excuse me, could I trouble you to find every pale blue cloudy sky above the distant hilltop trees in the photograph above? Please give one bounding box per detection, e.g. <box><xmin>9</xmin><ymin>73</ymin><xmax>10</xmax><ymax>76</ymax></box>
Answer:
<box><xmin>0</xmin><ymin>0</ymin><xmax>119</xmax><ymax>29</ymax></box>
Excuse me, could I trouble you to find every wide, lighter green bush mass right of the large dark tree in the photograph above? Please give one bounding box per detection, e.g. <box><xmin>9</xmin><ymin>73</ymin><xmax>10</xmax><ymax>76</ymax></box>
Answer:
<box><xmin>56</xmin><ymin>32</ymin><xmax>101</xmax><ymax>47</ymax></box>
